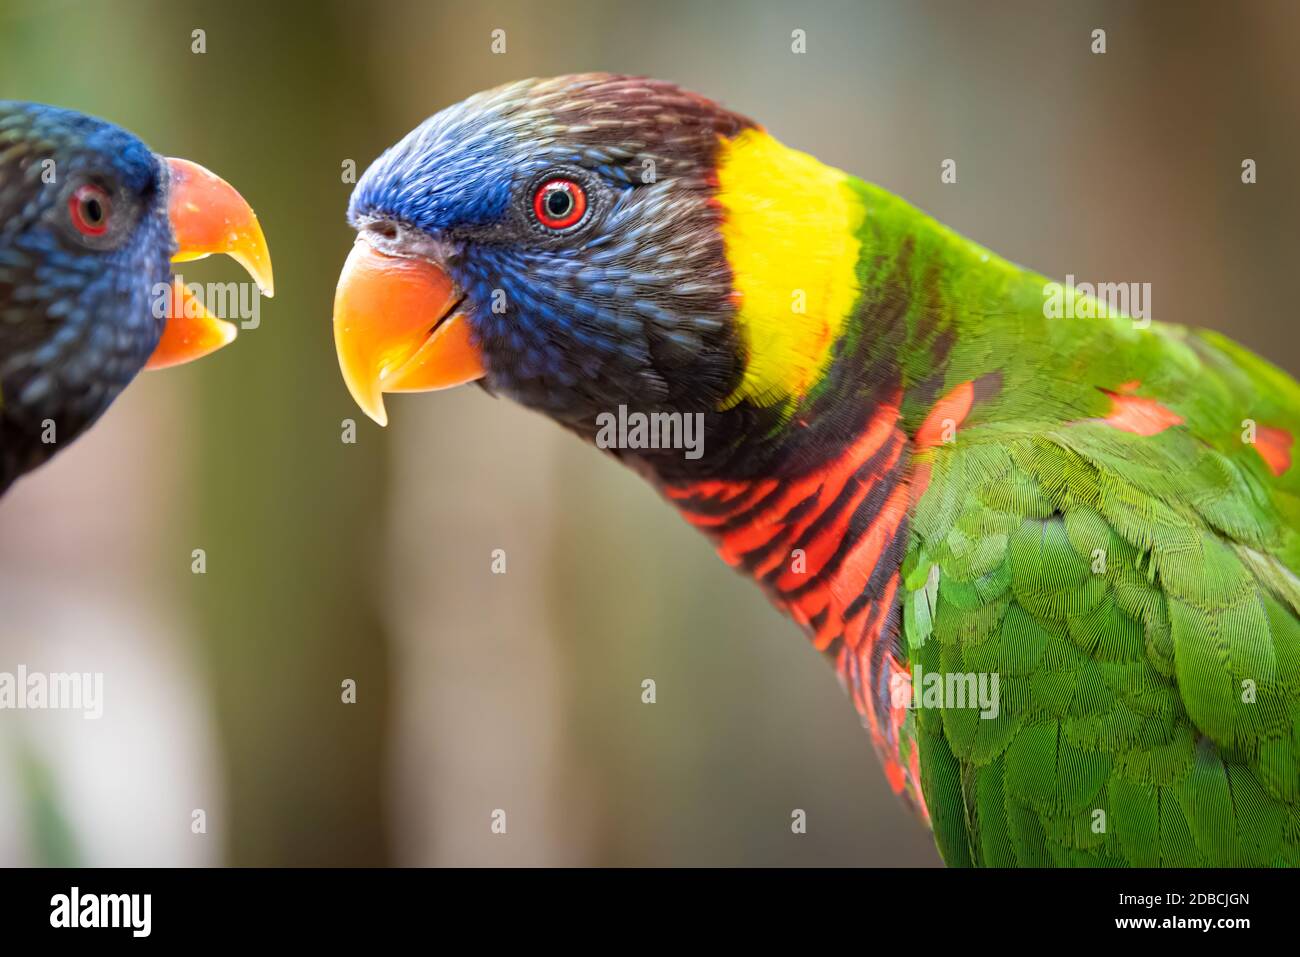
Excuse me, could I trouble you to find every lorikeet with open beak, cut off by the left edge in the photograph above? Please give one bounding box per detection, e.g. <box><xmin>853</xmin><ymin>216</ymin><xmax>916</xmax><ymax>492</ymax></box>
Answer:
<box><xmin>0</xmin><ymin>100</ymin><xmax>273</xmax><ymax>494</ymax></box>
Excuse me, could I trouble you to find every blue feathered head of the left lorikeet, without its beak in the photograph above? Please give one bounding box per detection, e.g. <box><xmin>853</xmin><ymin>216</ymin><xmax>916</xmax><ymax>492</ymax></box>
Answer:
<box><xmin>0</xmin><ymin>101</ymin><xmax>174</xmax><ymax>486</ymax></box>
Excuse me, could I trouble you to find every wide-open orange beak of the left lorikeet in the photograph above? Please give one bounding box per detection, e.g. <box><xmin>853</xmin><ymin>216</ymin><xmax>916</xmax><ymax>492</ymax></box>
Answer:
<box><xmin>144</xmin><ymin>159</ymin><xmax>276</xmax><ymax>369</ymax></box>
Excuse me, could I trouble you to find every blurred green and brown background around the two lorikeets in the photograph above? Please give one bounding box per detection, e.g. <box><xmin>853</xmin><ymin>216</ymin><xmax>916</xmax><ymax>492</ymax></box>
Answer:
<box><xmin>0</xmin><ymin>0</ymin><xmax>1300</xmax><ymax>866</ymax></box>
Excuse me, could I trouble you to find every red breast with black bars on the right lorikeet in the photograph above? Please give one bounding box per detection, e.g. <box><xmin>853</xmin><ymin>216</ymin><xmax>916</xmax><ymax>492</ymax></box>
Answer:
<box><xmin>650</xmin><ymin>391</ymin><xmax>927</xmax><ymax>815</ymax></box>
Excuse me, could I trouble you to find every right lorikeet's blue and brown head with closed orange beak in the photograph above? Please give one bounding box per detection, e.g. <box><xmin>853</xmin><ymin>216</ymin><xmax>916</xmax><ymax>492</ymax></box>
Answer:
<box><xmin>335</xmin><ymin>74</ymin><xmax>764</xmax><ymax>444</ymax></box>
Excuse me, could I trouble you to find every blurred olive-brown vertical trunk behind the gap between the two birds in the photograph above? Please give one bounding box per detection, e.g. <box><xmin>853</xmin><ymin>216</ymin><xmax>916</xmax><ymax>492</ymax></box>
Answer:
<box><xmin>158</xmin><ymin>3</ymin><xmax>389</xmax><ymax>865</ymax></box>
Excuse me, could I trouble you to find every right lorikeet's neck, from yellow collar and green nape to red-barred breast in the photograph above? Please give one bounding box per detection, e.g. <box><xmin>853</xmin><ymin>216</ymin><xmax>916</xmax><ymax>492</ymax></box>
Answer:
<box><xmin>618</xmin><ymin>151</ymin><xmax>1040</xmax><ymax>816</ymax></box>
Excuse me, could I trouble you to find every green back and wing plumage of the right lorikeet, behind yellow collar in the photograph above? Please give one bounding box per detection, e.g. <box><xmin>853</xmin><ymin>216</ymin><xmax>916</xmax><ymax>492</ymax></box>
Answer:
<box><xmin>854</xmin><ymin>174</ymin><xmax>1300</xmax><ymax>866</ymax></box>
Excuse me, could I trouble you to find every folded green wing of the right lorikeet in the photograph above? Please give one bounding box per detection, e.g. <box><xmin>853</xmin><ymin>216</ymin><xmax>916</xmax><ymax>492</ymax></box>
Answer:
<box><xmin>904</xmin><ymin>423</ymin><xmax>1300</xmax><ymax>866</ymax></box>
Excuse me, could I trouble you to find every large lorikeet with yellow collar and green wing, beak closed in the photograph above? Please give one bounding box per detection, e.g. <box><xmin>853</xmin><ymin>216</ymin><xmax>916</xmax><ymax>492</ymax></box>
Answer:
<box><xmin>334</xmin><ymin>74</ymin><xmax>1300</xmax><ymax>866</ymax></box>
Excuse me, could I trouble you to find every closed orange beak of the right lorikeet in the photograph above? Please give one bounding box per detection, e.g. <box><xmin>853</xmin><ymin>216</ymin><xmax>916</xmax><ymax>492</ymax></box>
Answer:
<box><xmin>334</xmin><ymin>237</ymin><xmax>485</xmax><ymax>425</ymax></box>
